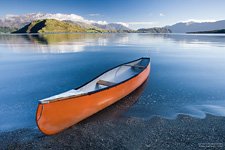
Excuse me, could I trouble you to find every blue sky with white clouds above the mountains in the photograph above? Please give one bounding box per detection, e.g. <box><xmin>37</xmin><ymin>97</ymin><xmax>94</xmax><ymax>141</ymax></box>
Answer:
<box><xmin>0</xmin><ymin>0</ymin><xmax>225</xmax><ymax>29</ymax></box>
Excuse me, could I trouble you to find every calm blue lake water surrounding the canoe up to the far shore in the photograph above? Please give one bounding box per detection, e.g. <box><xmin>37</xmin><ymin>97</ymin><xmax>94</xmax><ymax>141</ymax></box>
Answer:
<box><xmin>0</xmin><ymin>34</ymin><xmax>225</xmax><ymax>131</ymax></box>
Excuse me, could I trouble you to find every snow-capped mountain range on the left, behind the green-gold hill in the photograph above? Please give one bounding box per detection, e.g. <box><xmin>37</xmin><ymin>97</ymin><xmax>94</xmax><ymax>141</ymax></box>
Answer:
<box><xmin>0</xmin><ymin>13</ymin><xmax>130</xmax><ymax>31</ymax></box>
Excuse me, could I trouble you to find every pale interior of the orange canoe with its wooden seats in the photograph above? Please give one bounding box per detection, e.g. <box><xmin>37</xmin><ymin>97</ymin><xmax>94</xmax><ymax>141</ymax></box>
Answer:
<box><xmin>39</xmin><ymin>58</ymin><xmax>150</xmax><ymax>103</ymax></box>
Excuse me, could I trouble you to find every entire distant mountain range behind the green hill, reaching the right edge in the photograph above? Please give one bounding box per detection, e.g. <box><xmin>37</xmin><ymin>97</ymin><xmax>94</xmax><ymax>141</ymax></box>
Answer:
<box><xmin>4</xmin><ymin>13</ymin><xmax>225</xmax><ymax>33</ymax></box>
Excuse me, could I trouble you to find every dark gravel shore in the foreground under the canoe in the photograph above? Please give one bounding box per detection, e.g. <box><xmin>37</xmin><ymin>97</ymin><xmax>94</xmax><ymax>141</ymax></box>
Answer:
<box><xmin>0</xmin><ymin>82</ymin><xmax>225</xmax><ymax>150</ymax></box>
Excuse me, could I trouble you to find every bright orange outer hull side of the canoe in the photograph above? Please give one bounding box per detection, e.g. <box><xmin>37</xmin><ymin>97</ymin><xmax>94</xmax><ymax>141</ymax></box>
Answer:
<box><xmin>36</xmin><ymin>65</ymin><xmax>150</xmax><ymax>135</ymax></box>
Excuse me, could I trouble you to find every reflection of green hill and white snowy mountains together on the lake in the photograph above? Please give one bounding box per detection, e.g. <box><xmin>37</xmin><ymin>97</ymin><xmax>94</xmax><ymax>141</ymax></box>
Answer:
<box><xmin>0</xmin><ymin>33</ymin><xmax>132</xmax><ymax>54</ymax></box>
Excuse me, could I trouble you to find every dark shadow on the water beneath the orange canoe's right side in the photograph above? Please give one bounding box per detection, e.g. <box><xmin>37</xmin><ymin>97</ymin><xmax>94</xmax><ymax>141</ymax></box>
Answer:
<box><xmin>80</xmin><ymin>80</ymin><xmax>148</xmax><ymax>124</ymax></box>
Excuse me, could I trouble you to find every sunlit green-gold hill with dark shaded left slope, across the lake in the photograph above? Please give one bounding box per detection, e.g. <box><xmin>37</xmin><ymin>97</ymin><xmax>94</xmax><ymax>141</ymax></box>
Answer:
<box><xmin>13</xmin><ymin>19</ymin><xmax>105</xmax><ymax>33</ymax></box>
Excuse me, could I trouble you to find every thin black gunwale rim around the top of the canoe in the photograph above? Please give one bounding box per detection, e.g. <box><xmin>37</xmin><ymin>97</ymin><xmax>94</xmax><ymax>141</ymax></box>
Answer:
<box><xmin>39</xmin><ymin>57</ymin><xmax>151</xmax><ymax>104</ymax></box>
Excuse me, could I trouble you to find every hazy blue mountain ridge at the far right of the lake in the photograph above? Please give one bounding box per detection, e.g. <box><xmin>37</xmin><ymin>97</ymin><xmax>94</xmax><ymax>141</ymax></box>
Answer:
<box><xmin>166</xmin><ymin>20</ymin><xmax>225</xmax><ymax>33</ymax></box>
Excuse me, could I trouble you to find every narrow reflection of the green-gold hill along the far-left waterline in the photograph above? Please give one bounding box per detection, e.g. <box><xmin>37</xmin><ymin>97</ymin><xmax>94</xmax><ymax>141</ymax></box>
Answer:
<box><xmin>0</xmin><ymin>33</ymin><xmax>115</xmax><ymax>45</ymax></box>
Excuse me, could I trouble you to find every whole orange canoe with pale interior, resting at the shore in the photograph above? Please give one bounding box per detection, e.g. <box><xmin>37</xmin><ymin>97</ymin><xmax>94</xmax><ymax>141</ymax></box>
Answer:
<box><xmin>36</xmin><ymin>58</ymin><xmax>150</xmax><ymax>135</ymax></box>
